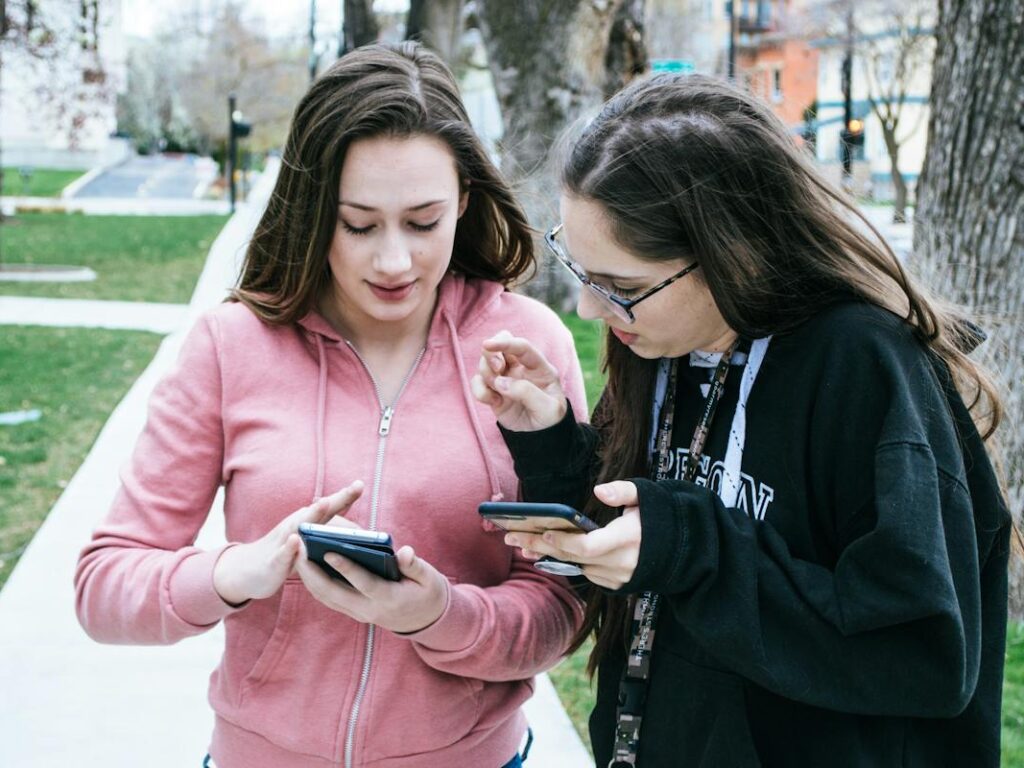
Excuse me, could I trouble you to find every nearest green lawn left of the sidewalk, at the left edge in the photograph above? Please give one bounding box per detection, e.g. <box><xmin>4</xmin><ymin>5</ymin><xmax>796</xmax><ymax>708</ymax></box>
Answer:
<box><xmin>0</xmin><ymin>326</ymin><xmax>161</xmax><ymax>587</ymax></box>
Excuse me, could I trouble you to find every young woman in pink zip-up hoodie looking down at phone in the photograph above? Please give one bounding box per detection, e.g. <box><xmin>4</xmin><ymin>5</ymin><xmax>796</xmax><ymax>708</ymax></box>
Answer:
<box><xmin>76</xmin><ymin>44</ymin><xmax>586</xmax><ymax>768</ymax></box>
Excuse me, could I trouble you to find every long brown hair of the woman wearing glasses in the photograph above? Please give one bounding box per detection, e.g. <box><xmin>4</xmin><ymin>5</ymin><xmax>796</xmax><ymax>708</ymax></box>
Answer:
<box><xmin>561</xmin><ymin>75</ymin><xmax>1001</xmax><ymax>673</ymax></box>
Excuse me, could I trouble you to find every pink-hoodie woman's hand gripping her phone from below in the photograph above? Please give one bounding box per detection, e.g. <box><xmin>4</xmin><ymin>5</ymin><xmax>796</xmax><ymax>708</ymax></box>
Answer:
<box><xmin>296</xmin><ymin>546</ymin><xmax>447</xmax><ymax>633</ymax></box>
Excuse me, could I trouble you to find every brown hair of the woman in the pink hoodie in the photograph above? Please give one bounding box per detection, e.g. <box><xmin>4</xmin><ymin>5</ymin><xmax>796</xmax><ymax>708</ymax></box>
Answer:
<box><xmin>231</xmin><ymin>42</ymin><xmax>535</xmax><ymax>324</ymax></box>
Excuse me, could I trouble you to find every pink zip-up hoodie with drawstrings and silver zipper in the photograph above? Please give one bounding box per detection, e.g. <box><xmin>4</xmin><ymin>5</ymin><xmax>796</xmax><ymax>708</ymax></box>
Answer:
<box><xmin>75</xmin><ymin>275</ymin><xmax>587</xmax><ymax>768</ymax></box>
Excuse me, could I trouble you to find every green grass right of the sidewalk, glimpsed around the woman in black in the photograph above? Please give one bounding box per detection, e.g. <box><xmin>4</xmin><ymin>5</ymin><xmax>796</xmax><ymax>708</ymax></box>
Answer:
<box><xmin>550</xmin><ymin>313</ymin><xmax>1024</xmax><ymax>768</ymax></box>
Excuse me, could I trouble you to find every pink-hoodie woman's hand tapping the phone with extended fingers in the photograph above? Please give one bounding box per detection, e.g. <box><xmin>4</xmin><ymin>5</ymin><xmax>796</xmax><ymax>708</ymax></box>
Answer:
<box><xmin>213</xmin><ymin>480</ymin><xmax>362</xmax><ymax>605</ymax></box>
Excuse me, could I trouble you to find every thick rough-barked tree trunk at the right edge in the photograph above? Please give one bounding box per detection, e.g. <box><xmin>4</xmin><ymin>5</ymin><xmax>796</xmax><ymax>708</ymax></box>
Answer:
<box><xmin>911</xmin><ymin>0</ymin><xmax>1024</xmax><ymax>616</ymax></box>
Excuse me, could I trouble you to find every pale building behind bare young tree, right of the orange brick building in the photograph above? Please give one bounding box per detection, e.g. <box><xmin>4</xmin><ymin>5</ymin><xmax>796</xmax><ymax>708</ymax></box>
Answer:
<box><xmin>813</xmin><ymin>0</ymin><xmax>934</xmax><ymax>201</ymax></box>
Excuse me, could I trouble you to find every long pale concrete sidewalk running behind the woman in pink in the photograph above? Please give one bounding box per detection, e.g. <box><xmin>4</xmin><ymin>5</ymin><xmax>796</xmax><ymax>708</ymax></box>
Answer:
<box><xmin>0</xmin><ymin>159</ymin><xmax>592</xmax><ymax>768</ymax></box>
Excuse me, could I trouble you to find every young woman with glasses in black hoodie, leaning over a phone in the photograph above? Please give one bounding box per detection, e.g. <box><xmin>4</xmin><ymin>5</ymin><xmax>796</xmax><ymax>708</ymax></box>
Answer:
<box><xmin>473</xmin><ymin>76</ymin><xmax>1012</xmax><ymax>768</ymax></box>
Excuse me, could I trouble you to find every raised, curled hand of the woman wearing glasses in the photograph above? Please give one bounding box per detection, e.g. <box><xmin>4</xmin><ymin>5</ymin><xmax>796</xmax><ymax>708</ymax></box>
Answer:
<box><xmin>472</xmin><ymin>331</ymin><xmax>567</xmax><ymax>432</ymax></box>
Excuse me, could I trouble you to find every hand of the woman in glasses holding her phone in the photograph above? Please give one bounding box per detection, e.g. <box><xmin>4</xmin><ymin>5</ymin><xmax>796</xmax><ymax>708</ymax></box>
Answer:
<box><xmin>505</xmin><ymin>480</ymin><xmax>640</xmax><ymax>590</ymax></box>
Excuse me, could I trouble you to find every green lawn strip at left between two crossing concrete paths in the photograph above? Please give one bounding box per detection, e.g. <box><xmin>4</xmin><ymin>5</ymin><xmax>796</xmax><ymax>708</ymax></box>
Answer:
<box><xmin>0</xmin><ymin>213</ymin><xmax>227</xmax><ymax>304</ymax></box>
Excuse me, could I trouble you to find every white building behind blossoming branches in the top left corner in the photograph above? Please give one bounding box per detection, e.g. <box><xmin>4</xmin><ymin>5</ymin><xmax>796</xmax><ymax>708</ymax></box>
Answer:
<box><xmin>0</xmin><ymin>0</ymin><xmax>129</xmax><ymax>169</ymax></box>
